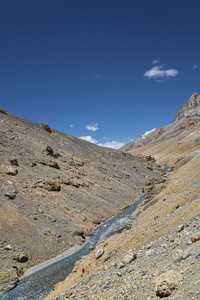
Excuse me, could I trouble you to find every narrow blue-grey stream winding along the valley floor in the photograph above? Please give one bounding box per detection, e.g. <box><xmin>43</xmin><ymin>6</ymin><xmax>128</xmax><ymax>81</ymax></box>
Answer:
<box><xmin>1</xmin><ymin>193</ymin><xmax>145</xmax><ymax>300</ymax></box>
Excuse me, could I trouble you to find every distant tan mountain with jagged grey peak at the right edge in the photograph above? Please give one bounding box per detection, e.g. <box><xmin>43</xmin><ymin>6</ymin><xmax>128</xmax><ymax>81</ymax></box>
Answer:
<box><xmin>120</xmin><ymin>93</ymin><xmax>200</xmax><ymax>165</ymax></box>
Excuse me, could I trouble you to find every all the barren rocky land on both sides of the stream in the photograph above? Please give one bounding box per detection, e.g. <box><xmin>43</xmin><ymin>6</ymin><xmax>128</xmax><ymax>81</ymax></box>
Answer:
<box><xmin>0</xmin><ymin>94</ymin><xmax>200</xmax><ymax>300</ymax></box>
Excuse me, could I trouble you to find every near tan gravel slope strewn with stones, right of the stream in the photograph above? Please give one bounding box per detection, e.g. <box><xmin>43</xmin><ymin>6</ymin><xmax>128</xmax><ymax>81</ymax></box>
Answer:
<box><xmin>46</xmin><ymin>153</ymin><xmax>200</xmax><ymax>300</ymax></box>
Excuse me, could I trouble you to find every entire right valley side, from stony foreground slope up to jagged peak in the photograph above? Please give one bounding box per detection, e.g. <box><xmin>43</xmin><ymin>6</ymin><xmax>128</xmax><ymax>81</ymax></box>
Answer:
<box><xmin>45</xmin><ymin>93</ymin><xmax>200</xmax><ymax>300</ymax></box>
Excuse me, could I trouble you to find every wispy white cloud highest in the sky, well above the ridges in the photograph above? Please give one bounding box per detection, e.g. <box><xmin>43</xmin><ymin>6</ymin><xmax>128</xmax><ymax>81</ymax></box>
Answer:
<box><xmin>144</xmin><ymin>66</ymin><xmax>178</xmax><ymax>81</ymax></box>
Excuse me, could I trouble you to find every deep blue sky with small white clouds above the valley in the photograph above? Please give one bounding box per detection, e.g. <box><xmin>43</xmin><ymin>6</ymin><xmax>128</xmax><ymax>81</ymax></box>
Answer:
<box><xmin>0</xmin><ymin>0</ymin><xmax>200</xmax><ymax>148</ymax></box>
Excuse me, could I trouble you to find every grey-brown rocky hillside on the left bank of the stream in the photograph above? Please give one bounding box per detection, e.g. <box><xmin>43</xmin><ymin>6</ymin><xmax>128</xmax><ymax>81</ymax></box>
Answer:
<box><xmin>0</xmin><ymin>109</ymin><xmax>165</xmax><ymax>291</ymax></box>
